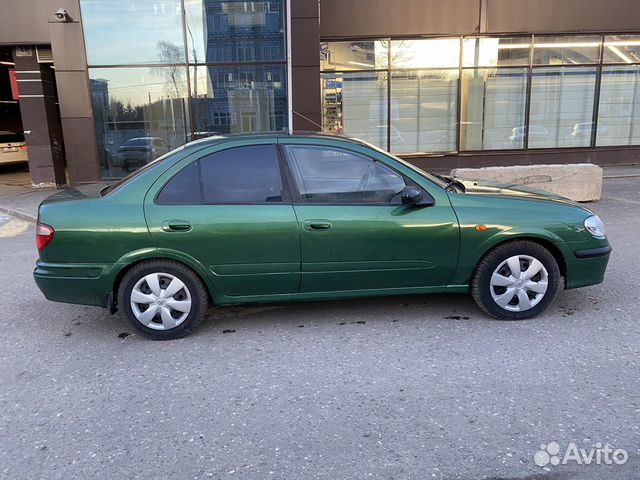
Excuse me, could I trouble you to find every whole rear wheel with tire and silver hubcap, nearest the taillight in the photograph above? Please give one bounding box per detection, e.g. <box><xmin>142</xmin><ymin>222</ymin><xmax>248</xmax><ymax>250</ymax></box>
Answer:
<box><xmin>118</xmin><ymin>260</ymin><xmax>209</xmax><ymax>340</ymax></box>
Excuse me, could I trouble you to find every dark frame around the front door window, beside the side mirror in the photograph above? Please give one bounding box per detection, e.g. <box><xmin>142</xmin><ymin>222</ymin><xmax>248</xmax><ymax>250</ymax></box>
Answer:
<box><xmin>278</xmin><ymin>142</ymin><xmax>435</xmax><ymax>208</ymax></box>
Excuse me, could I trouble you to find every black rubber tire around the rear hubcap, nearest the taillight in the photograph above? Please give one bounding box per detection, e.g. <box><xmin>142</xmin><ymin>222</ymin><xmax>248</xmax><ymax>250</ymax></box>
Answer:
<box><xmin>118</xmin><ymin>260</ymin><xmax>209</xmax><ymax>340</ymax></box>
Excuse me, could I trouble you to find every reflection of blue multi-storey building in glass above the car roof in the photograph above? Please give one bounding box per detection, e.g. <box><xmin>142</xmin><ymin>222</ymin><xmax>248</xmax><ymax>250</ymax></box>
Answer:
<box><xmin>192</xmin><ymin>0</ymin><xmax>287</xmax><ymax>135</ymax></box>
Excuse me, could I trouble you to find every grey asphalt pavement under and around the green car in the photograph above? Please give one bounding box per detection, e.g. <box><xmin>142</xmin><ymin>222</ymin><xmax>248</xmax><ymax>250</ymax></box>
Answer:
<box><xmin>0</xmin><ymin>178</ymin><xmax>640</xmax><ymax>480</ymax></box>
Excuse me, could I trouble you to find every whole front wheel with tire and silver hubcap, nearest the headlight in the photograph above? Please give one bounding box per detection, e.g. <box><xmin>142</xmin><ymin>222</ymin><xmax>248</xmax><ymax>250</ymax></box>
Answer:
<box><xmin>471</xmin><ymin>240</ymin><xmax>562</xmax><ymax>320</ymax></box>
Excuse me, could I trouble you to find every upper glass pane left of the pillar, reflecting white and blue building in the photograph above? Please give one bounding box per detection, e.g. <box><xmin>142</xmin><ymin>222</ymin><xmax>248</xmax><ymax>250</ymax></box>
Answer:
<box><xmin>184</xmin><ymin>0</ymin><xmax>286</xmax><ymax>63</ymax></box>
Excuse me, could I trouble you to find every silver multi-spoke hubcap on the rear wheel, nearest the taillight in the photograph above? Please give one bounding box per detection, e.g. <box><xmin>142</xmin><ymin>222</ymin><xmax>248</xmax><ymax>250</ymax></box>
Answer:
<box><xmin>130</xmin><ymin>272</ymin><xmax>191</xmax><ymax>330</ymax></box>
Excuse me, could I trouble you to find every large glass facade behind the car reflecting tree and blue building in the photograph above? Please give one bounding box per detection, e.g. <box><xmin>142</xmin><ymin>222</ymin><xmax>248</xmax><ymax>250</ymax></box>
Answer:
<box><xmin>82</xmin><ymin>0</ymin><xmax>288</xmax><ymax>177</ymax></box>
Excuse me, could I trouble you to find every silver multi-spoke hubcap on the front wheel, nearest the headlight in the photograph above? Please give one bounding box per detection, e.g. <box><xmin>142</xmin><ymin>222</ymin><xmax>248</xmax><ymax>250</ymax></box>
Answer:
<box><xmin>490</xmin><ymin>255</ymin><xmax>549</xmax><ymax>312</ymax></box>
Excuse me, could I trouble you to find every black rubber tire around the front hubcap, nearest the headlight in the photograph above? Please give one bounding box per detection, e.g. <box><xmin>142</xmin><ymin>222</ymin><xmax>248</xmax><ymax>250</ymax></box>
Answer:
<box><xmin>471</xmin><ymin>240</ymin><xmax>563</xmax><ymax>320</ymax></box>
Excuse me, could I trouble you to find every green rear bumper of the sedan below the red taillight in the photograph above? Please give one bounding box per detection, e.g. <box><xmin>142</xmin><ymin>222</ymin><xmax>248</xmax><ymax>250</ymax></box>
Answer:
<box><xmin>33</xmin><ymin>261</ymin><xmax>113</xmax><ymax>306</ymax></box>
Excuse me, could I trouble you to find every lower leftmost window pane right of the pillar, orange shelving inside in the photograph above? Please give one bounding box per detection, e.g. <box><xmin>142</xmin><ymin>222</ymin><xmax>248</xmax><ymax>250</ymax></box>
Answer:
<box><xmin>322</xmin><ymin>72</ymin><xmax>389</xmax><ymax>149</ymax></box>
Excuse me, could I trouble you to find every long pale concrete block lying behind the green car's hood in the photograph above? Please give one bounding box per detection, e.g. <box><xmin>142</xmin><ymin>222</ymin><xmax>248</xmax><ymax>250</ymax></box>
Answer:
<box><xmin>451</xmin><ymin>163</ymin><xmax>602</xmax><ymax>202</ymax></box>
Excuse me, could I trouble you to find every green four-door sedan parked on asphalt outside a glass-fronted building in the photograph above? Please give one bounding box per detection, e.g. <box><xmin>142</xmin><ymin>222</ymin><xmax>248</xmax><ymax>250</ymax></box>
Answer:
<box><xmin>34</xmin><ymin>133</ymin><xmax>611</xmax><ymax>339</ymax></box>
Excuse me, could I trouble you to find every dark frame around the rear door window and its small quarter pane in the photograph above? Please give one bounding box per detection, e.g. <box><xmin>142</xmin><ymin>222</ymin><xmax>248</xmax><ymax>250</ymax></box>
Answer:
<box><xmin>153</xmin><ymin>142</ymin><xmax>292</xmax><ymax>207</ymax></box>
